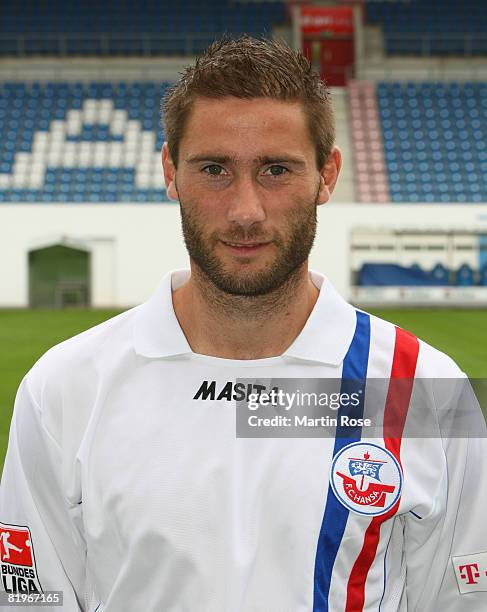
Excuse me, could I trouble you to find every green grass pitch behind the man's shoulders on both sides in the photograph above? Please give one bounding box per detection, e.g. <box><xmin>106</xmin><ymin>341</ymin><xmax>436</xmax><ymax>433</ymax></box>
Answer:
<box><xmin>0</xmin><ymin>309</ymin><xmax>487</xmax><ymax>470</ymax></box>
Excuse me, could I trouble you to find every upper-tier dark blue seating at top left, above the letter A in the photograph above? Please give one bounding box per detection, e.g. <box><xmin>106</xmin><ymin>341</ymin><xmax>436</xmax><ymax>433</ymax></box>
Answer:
<box><xmin>0</xmin><ymin>0</ymin><xmax>286</xmax><ymax>56</ymax></box>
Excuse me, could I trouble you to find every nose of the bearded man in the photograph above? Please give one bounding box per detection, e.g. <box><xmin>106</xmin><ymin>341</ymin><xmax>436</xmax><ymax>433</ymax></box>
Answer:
<box><xmin>227</xmin><ymin>176</ymin><xmax>266</xmax><ymax>229</ymax></box>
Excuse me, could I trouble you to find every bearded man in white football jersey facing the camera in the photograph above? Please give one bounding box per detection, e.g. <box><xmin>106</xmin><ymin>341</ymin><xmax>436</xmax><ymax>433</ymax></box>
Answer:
<box><xmin>0</xmin><ymin>37</ymin><xmax>487</xmax><ymax>612</ymax></box>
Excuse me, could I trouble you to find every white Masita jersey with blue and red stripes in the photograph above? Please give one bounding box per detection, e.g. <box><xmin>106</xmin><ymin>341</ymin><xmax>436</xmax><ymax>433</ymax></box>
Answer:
<box><xmin>0</xmin><ymin>270</ymin><xmax>487</xmax><ymax>612</ymax></box>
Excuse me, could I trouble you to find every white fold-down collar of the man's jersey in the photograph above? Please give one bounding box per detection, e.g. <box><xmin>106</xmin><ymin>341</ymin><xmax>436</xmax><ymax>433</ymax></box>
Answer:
<box><xmin>134</xmin><ymin>270</ymin><xmax>356</xmax><ymax>365</ymax></box>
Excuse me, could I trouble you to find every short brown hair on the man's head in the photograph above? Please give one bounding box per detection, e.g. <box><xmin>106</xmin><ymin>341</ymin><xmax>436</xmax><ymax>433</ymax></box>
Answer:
<box><xmin>162</xmin><ymin>36</ymin><xmax>335</xmax><ymax>169</ymax></box>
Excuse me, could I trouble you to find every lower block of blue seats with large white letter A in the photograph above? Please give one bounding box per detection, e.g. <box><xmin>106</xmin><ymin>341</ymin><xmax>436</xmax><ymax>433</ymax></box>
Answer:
<box><xmin>0</xmin><ymin>82</ymin><xmax>169</xmax><ymax>202</ymax></box>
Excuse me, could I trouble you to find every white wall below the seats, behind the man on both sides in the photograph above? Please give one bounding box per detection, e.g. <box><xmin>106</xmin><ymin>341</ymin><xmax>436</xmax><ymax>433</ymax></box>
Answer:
<box><xmin>0</xmin><ymin>203</ymin><xmax>487</xmax><ymax>308</ymax></box>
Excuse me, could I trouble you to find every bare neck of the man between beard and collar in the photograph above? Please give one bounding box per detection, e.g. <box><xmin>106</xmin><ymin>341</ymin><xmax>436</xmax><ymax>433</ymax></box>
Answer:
<box><xmin>172</xmin><ymin>265</ymin><xmax>319</xmax><ymax>359</ymax></box>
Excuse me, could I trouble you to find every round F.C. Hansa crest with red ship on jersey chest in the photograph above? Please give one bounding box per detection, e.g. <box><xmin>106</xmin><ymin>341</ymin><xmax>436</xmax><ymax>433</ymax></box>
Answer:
<box><xmin>330</xmin><ymin>442</ymin><xmax>402</xmax><ymax>516</ymax></box>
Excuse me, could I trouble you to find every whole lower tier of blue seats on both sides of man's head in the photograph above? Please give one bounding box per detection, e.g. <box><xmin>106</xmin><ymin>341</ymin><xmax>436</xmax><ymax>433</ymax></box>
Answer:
<box><xmin>0</xmin><ymin>81</ymin><xmax>487</xmax><ymax>203</ymax></box>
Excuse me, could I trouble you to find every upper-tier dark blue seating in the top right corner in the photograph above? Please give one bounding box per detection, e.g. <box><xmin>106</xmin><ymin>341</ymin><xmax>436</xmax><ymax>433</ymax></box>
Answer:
<box><xmin>365</xmin><ymin>0</ymin><xmax>487</xmax><ymax>56</ymax></box>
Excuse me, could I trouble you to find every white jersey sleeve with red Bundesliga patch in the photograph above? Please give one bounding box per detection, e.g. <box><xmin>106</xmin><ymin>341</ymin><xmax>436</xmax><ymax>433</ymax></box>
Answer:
<box><xmin>0</xmin><ymin>377</ymin><xmax>92</xmax><ymax>612</ymax></box>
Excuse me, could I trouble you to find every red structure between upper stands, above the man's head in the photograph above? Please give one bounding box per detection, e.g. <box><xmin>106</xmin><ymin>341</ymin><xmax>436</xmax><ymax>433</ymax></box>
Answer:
<box><xmin>299</xmin><ymin>5</ymin><xmax>355</xmax><ymax>86</ymax></box>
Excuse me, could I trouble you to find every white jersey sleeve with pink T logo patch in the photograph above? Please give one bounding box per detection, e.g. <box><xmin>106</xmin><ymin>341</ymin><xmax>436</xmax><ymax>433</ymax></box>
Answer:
<box><xmin>405</xmin><ymin>378</ymin><xmax>487</xmax><ymax>612</ymax></box>
